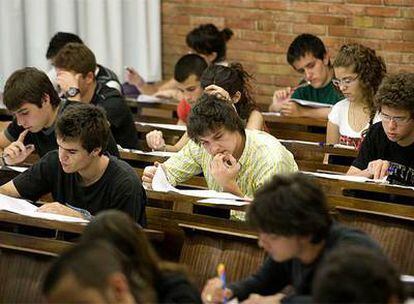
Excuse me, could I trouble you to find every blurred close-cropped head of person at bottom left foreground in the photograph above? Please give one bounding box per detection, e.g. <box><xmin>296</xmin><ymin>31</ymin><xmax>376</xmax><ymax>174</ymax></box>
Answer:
<box><xmin>42</xmin><ymin>240</ymin><xmax>155</xmax><ymax>304</ymax></box>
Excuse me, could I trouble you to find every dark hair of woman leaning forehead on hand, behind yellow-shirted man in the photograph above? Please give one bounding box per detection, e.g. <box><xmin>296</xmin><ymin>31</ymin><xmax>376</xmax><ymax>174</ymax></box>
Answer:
<box><xmin>200</xmin><ymin>62</ymin><xmax>257</xmax><ymax>120</ymax></box>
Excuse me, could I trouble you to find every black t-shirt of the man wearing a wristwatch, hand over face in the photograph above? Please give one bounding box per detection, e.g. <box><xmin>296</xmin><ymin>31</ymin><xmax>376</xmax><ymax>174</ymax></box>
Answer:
<box><xmin>91</xmin><ymin>83</ymin><xmax>138</xmax><ymax>149</ymax></box>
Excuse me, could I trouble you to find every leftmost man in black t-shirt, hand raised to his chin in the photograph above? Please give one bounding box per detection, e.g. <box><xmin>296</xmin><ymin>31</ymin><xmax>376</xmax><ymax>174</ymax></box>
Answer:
<box><xmin>0</xmin><ymin>67</ymin><xmax>119</xmax><ymax>165</ymax></box>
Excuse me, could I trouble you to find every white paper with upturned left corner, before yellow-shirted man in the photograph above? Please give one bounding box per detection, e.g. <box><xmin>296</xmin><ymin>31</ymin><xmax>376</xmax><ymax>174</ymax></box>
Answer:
<box><xmin>152</xmin><ymin>166</ymin><xmax>244</xmax><ymax>200</ymax></box>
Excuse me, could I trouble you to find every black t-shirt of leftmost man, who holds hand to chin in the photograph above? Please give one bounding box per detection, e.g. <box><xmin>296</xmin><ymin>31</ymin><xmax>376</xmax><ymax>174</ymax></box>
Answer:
<box><xmin>4</xmin><ymin>100</ymin><xmax>119</xmax><ymax>157</ymax></box>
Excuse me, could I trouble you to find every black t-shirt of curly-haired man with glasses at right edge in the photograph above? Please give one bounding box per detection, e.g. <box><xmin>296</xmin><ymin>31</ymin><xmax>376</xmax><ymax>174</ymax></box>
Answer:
<box><xmin>352</xmin><ymin>122</ymin><xmax>414</xmax><ymax>170</ymax></box>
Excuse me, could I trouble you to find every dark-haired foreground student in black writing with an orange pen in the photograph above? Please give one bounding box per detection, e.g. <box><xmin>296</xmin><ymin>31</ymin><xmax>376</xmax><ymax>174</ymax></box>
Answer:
<box><xmin>201</xmin><ymin>173</ymin><xmax>382</xmax><ymax>303</ymax></box>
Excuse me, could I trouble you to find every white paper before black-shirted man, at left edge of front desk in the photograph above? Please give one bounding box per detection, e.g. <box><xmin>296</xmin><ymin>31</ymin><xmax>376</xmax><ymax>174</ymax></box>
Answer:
<box><xmin>0</xmin><ymin>194</ymin><xmax>88</xmax><ymax>223</ymax></box>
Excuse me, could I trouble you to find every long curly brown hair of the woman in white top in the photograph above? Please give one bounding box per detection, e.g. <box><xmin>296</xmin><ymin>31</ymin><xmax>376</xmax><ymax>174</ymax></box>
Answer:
<box><xmin>333</xmin><ymin>43</ymin><xmax>387</xmax><ymax>118</ymax></box>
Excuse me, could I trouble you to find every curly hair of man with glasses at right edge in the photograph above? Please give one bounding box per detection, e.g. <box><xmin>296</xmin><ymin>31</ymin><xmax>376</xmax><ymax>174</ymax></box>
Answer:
<box><xmin>375</xmin><ymin>73</ymin><xmax>414</xmax><ymax>118</ymax></box>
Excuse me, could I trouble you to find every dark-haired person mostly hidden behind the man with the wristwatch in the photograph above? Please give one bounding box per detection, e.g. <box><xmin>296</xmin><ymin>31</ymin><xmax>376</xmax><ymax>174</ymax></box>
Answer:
<box><xmin>46</xmin><ymin>32</ymin><xmax>122</xmax><ymax>93</ymax></box>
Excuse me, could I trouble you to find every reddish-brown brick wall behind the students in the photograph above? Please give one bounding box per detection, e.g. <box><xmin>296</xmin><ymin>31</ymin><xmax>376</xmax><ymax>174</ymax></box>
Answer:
<box><xmin>162</xmin><ymin>0</ymin><xmax>414</xmax><ymax>106</ymax></box>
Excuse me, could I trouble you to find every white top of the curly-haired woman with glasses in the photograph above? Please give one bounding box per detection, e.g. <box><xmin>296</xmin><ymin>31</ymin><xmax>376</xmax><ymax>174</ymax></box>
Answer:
<box><xmin>328</xmin><ymin>99</ymin><xmax>381</xmax><ymax>138</ymax></box>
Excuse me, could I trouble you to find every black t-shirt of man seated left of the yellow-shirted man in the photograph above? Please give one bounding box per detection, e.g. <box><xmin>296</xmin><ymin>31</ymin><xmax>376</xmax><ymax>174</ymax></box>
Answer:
<box><xmin>13</xmin><ymin>151</ymin><xmax>146</xmax><ymax>226</ymax></box>
